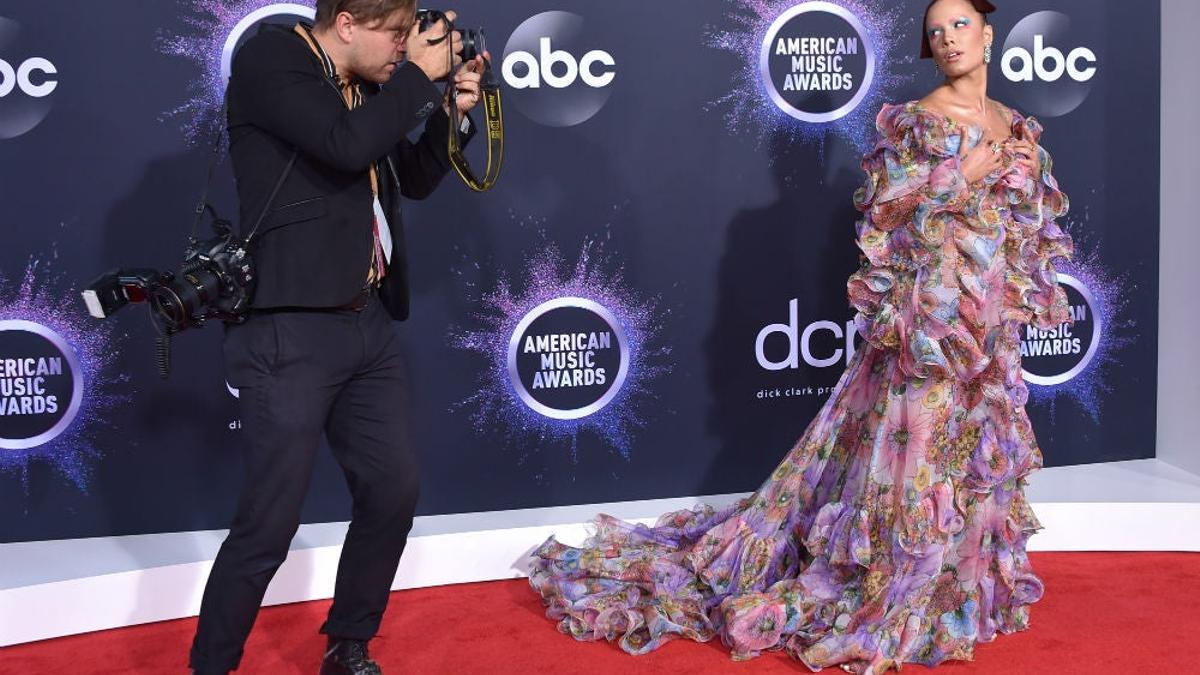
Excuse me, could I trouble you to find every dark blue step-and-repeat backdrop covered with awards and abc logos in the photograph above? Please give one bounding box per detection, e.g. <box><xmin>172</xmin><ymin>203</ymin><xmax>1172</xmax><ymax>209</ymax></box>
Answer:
<box><xmin>0</xmin><ymin>0</ymin><xmax>1170</xmax><ymax>542</ymax></box>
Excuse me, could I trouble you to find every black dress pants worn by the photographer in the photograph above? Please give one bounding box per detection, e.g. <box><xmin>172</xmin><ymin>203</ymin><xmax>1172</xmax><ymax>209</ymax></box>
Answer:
<box><xmin>191</xmin><ymin>294</ymin><xmax>418</xmax><ymax>673</ymax></box>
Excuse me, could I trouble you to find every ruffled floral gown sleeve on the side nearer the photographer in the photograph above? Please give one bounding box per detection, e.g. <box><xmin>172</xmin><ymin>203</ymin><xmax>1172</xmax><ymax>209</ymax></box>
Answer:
<box><xmin>847</xmin><ymin>107</ymin><xmax>986</xmax><ymax>380</ymax></box>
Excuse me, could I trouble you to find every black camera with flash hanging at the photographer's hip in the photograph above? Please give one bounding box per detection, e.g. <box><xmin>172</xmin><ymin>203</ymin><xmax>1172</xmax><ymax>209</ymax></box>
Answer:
<box><xmin>83</xmin><ymin>212</ymin><xmax>254</xmax><ymax>335</ymax></box>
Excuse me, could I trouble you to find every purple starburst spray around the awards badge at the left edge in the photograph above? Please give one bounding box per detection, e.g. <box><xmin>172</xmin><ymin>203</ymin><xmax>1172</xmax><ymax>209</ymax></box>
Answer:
<box><xmin>0</xmin><ymin>259</ymin><xmax>128</xmax><ymax>492</ymax></box>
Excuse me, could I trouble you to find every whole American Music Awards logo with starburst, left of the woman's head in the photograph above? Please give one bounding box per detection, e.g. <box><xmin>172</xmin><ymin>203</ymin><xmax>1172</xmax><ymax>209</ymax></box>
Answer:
<box><xmin>707</xmin><ymin>0</ymin><xmax>913</xmax><ymax>150</ymax></box>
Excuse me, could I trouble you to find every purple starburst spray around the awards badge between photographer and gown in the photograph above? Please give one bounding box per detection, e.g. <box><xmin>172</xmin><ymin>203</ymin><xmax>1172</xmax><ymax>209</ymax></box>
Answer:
<box><xmin>450</xmin><ymin>233</ymin><xmax>671</xmax><ymax>460</ymax></box>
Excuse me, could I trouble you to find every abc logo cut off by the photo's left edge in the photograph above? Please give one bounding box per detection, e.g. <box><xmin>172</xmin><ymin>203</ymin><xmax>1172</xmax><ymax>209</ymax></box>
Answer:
<box><xmin>0</xmin><ymin>17</ymin><xmax>59</xmax><ymax>141</ymax></box>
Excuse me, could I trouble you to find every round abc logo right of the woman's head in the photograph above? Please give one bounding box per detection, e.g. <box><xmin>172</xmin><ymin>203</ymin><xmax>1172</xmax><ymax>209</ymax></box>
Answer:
<box><xmin>1000</xmin><ymin>11</ymin><xmax>1099</xmax><ymax>117</ymax></box>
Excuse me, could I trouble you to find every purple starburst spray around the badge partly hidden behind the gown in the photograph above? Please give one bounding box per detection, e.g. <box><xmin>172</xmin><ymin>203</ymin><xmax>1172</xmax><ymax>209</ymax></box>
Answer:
<box><xmin>1028</xmin><ymin>214</ymin><xmax>1138</xmax><ymax>423</ymax></box>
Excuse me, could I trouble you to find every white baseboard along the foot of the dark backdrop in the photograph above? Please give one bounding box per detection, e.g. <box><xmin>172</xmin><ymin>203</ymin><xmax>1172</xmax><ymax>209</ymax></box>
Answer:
<box><xmin>0</xmin><ymin>460</ymin><xmax>1200</xmax><ymax>646</ymax></box>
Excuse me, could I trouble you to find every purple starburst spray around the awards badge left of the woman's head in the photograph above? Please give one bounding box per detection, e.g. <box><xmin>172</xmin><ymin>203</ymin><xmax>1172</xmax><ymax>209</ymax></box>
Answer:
<box><xmin>707</xmin><ymin>0</ymin><xmax>914</xmax><ymax>151</ymax></box>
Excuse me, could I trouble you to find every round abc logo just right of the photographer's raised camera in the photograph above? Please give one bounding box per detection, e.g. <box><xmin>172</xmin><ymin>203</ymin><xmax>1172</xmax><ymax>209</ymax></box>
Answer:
<box><xmin>500</xmin><ymin>11</ymin><xmax>617</xmax><ymax>126</ymax></box>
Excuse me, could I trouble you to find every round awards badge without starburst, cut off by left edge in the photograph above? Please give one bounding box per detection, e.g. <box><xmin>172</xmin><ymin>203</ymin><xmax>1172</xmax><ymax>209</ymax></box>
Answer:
<box><xmin>0</xmin><ymin>319</ymin><xmax>83</xmax><ymax>450</ymax></box>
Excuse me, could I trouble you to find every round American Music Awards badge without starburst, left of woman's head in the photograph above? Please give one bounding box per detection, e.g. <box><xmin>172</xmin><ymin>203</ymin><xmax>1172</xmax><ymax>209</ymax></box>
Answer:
<box><xmin>758</xmin><ymin>1</ymin><xmax>875</xmax><ymax>124</ymax></box>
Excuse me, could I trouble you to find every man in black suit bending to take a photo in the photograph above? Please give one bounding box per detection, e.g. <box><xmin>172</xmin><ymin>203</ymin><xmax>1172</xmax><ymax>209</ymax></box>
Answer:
<box><xmin>191</xmin><ymin>0</ymin><xmax>486</xmax><ymax>675</ymax></box>
